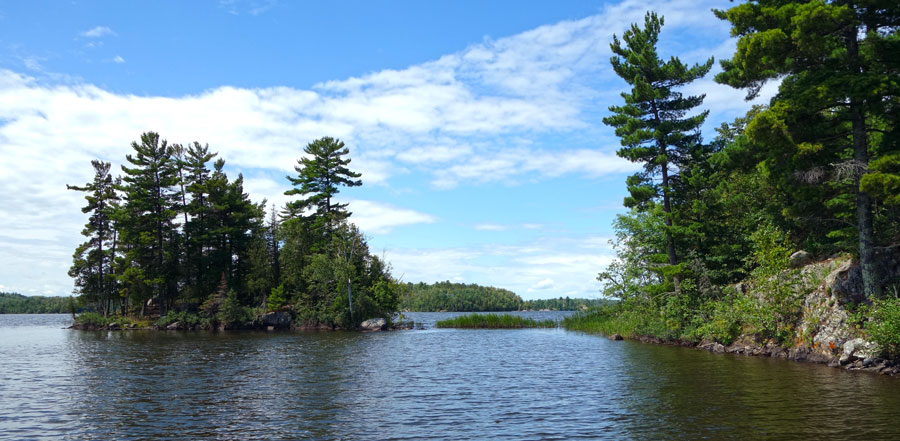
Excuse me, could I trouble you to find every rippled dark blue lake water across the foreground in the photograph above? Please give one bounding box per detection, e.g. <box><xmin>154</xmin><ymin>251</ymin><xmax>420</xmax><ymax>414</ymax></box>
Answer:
<box><xmin>0</xmin><ymin>313</ymin><xmax>900</xmax><ymax>440</ymax></box>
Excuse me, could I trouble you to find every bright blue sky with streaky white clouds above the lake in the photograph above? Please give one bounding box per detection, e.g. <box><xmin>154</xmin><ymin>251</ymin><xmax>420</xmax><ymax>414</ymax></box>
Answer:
<box><xmin>0</xmin><ymin>0</ymin><xmax>774</xmax><ymax>299</ymax></box>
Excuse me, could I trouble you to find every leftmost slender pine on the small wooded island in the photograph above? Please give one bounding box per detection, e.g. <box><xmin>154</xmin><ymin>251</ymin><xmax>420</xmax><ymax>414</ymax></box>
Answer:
<box><xmin>66</xmin><ymin>160</ymin><xmax>119</xmax><ymax>316</ymax></box>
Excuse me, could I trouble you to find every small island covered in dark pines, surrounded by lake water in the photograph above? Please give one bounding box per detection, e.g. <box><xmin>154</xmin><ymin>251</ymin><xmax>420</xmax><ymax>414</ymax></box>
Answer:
<box><xmin>69</xmin><ymin>136</ymin><xmax>400</xmax><ymax>329</ymax></box>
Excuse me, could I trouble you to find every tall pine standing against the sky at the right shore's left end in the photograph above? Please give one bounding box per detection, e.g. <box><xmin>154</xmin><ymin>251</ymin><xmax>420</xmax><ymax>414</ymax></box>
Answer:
<box><xmin>603</xmin><ymin>12</ymin><xmax>713</xmax><ymax>290</ymax></box>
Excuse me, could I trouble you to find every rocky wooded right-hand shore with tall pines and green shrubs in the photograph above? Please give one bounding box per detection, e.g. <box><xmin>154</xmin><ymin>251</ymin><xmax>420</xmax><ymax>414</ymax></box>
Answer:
<box><xmin>566</xmin><ymin>1</ymin><xmax>900</xmax><ymax>369</ymax></box>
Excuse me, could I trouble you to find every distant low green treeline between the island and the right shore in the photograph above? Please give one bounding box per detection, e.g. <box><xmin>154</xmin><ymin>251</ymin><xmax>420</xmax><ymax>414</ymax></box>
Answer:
<box><xmin>400</xmin><ymin>281</ymin><xmax>603</xmax><ymax>312</ymax></box>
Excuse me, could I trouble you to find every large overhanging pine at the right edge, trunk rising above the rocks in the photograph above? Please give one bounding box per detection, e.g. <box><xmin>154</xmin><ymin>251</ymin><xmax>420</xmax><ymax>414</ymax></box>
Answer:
<box><xmin>715</xmin><ymin>0</ymin><xmax>900</xmax><ymax>296</ymax></box>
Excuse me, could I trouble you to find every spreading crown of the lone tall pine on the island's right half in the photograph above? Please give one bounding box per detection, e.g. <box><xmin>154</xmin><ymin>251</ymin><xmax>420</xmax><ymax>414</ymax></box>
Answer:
<box><xmin>284</xmin><ymin>137</ymin><xmax>362</xmax><ymax>229</ymax></box>
